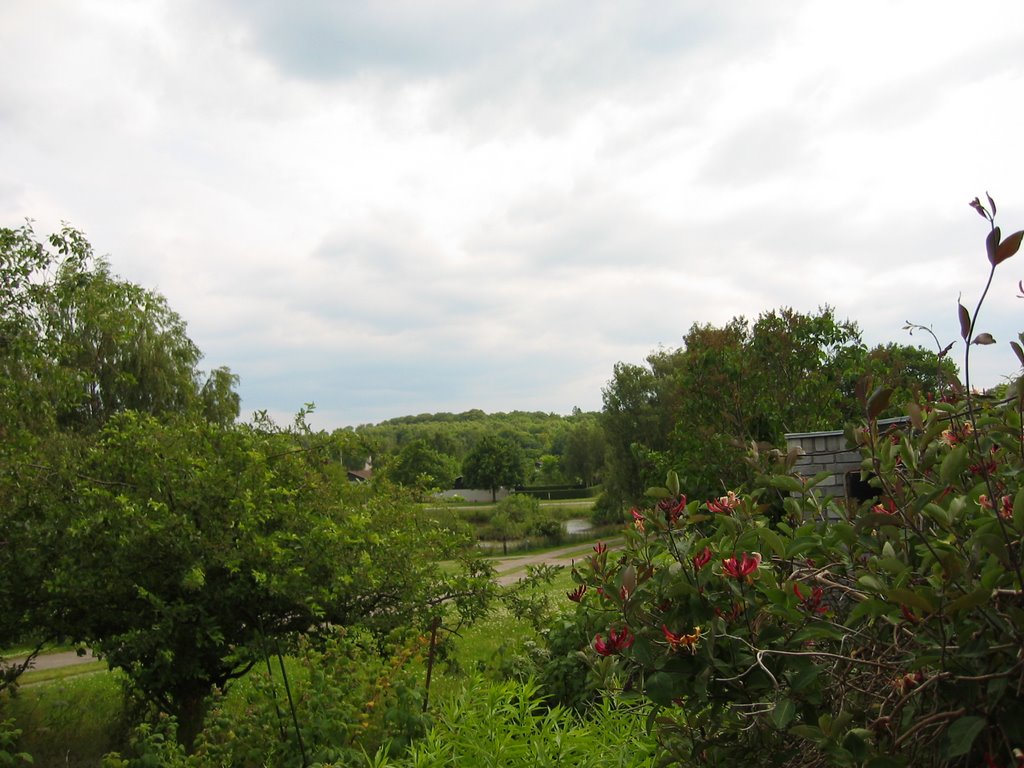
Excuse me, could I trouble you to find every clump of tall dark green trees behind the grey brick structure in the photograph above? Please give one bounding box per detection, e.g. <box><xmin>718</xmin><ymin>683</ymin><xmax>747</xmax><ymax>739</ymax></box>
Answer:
<box><xmin>601</xmin><ymin>306</ymin><xmax>953</xmax><ymax>514</ymax></box>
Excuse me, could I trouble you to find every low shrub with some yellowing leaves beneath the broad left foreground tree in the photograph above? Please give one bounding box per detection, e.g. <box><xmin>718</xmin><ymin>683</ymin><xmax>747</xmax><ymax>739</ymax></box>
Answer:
<box><xmin>105</xmin><ymin>630</ymin><xmax>429</xmax><ymax>768</ymax></box>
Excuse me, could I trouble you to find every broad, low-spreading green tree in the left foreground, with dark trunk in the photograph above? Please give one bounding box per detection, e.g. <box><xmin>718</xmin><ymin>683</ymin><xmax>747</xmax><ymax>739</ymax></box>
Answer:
<box><xmin>40</xmin><ymin>412</ymin><xmax>485</xmax><ymax>745</ymax></box>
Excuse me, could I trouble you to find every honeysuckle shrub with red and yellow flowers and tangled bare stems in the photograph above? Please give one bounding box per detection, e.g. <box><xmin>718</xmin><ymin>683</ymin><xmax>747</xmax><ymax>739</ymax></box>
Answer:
<box><xmin>571</xmin><ymin>201</ymin><xmax>1024</xmax><ymax>768</ymax></box>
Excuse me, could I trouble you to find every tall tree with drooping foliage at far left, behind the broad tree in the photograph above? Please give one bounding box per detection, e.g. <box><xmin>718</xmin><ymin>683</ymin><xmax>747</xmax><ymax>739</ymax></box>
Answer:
<box><xmin>0</xmin><ymin>223</ymin><xmax>239</xmax><ymax>432</ymax></box>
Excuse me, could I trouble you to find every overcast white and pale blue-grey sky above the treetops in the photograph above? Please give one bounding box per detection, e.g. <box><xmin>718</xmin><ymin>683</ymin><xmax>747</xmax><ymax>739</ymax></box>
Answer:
<box><xmin>0</xmin><ymin>0</ymin><xmax>1024</xmax><ymax>428</ymax></box>
